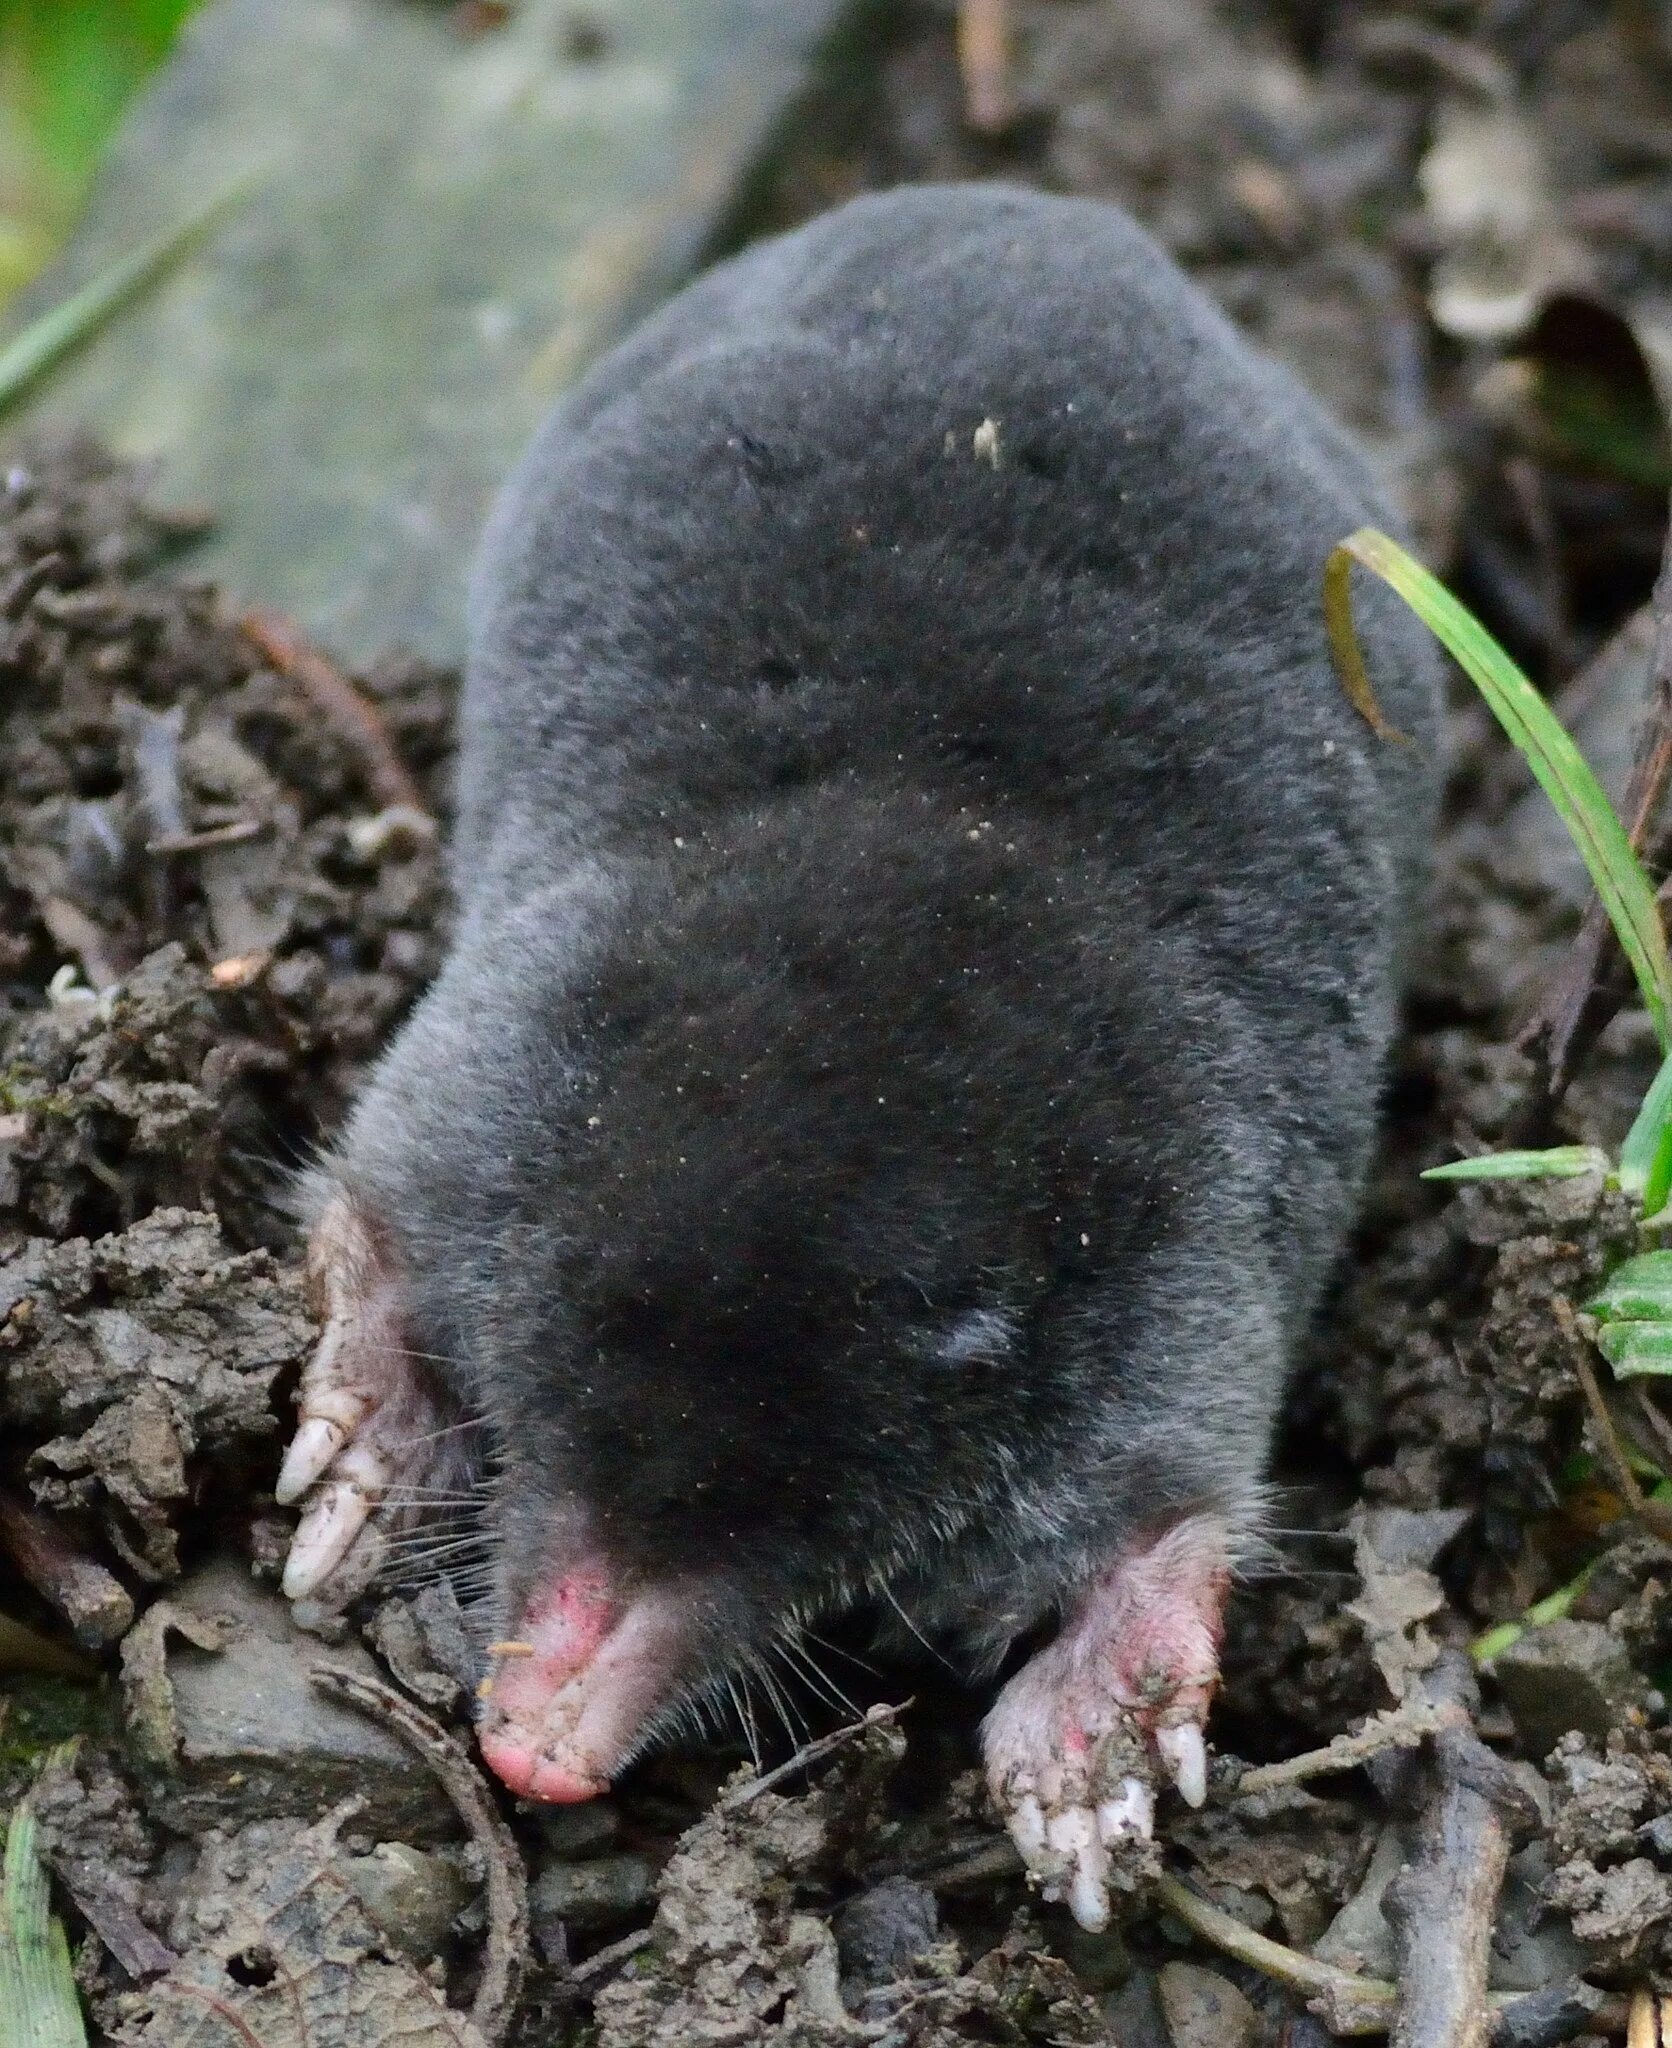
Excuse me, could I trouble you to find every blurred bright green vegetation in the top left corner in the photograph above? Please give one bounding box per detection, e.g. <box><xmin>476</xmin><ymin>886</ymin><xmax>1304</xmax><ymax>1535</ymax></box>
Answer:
<box><xmin>0</xmin><ymin>0</ymin><xmax>201</xmax><ymax>303</ymax></box>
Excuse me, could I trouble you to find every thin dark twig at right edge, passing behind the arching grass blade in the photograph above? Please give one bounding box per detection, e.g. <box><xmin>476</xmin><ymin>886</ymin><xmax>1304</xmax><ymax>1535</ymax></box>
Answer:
<box><xmin>1518</xmin><ymin>526</ymin><xmax>1672</xmax><ymax>1114</ymax></box>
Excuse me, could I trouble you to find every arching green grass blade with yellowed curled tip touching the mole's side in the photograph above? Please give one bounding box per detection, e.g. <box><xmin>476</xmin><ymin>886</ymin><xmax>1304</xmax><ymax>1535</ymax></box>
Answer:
<box><xmin>1324</xmin><ymin>526</ymin><xmax>1672</xmax><ymax>1051</ymax></box>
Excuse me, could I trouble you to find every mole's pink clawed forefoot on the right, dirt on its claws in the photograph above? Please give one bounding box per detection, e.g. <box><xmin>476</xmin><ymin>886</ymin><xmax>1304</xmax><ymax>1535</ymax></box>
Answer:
<box><xmin>981</xmin><ymin>1516</ymin><xmax>1231</xmax><ymax>1929</ymax></box>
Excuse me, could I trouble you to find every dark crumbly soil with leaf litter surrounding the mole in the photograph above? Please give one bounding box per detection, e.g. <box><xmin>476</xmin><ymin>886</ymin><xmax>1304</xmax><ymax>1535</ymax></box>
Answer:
<box><xmin>0</xmin><ymin>0</ymin><xmax>1672</xmax><ymax>2048</ymax></box>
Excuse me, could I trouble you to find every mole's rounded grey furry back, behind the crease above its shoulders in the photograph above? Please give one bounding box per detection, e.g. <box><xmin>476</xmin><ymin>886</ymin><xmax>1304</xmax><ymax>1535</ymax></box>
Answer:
<box><xmin>461</xmin><ymin>186</ymin><xmax>1434</xmax><ymax>937</ymax></box>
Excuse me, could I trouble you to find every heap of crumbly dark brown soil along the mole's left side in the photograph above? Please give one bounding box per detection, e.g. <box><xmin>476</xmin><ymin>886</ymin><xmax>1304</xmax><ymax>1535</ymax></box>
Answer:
<box><xmin>0</xmin><ymin>446</ymin><xmax>447</xmax><ymax>1597</ymax></box>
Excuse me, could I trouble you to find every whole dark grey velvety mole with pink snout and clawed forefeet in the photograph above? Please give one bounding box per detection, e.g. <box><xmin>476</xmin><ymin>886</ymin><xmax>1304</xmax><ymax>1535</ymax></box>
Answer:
<box><xmin>279</xmin><ymin>184</ymin><xmax>1438</xmax><ymax>1927</ymax></box>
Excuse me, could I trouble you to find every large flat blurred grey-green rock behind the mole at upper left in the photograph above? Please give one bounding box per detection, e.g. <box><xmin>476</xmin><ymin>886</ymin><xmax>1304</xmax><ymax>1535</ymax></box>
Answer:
<box><xmin>31</xmin><ymin>0</ymin><xmax>860</xmax><ymax>659</ymax></box>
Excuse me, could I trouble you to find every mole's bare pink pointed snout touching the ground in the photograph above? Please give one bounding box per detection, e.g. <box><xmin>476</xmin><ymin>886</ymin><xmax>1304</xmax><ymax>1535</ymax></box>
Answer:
<box><xmin>482</xmin><ymin>1565</ymin><xmax>691</xmax><ymax>1804</ymax></box>
